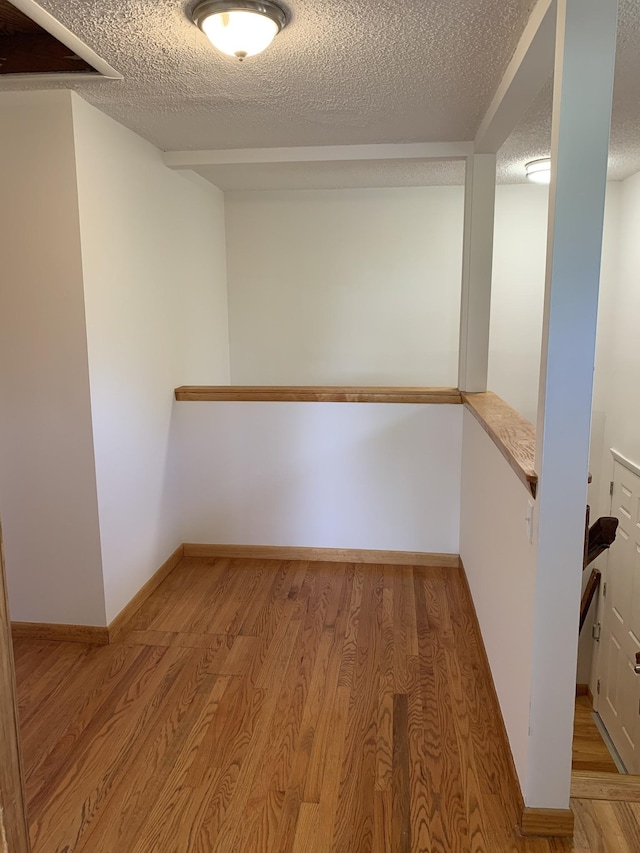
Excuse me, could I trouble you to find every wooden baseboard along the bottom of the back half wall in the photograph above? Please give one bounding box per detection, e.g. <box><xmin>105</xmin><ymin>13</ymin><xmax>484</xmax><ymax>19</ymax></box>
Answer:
<box><xmin>183</xmin><ymin>542</ymin><xmax>460</xmax><ymax>568</ymax></box>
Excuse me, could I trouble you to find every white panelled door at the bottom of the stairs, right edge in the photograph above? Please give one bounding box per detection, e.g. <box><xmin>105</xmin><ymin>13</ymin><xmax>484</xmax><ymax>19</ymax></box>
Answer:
<box><xmin>598</xmin><ymin>461</ymin><xmax>640</xmax><ymax>773</ymax></box>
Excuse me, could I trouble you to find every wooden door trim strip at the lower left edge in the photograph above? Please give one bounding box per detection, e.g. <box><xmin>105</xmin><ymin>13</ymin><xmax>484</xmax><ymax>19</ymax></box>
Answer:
<box><xmin>0</xmin><ymin>526</ymin><xmax>31</xmax><ymax>853</ymax></box>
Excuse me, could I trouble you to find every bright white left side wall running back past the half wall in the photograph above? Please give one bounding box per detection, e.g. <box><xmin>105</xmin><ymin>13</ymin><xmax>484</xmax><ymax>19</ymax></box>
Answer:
<box><xmin>73</xmin><ymin>96</ymin><xmax>229</xmax><ymax>621</ymax></box>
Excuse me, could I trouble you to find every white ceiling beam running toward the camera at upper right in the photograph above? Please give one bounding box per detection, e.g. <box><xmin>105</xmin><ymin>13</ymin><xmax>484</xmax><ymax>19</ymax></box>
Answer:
<box><xmin>474</xmin><ymin>0</ymin><xmax>556</xmax><ymax>154</ymax></box>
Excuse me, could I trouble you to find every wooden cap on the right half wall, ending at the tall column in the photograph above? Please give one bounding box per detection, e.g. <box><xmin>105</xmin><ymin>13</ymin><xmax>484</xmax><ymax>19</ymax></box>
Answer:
<box><xmin>462</xmin><ymin>391</ymin><xmax>538</xmax><ymax>498</ymax></box>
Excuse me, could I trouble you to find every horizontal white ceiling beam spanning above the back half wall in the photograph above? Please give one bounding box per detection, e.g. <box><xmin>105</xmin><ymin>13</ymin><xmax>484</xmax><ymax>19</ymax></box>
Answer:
<box><xmin>164</xmin><ymin>142</ymin><xmax>473</xmax><ymax>169</ymax></box>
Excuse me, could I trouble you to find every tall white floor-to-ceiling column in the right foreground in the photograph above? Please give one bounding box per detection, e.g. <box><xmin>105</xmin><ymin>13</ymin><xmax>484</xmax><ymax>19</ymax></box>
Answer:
<box><xmin>525</xmin><ymin>0</ymin><xmax>617</xmax><ymax>808</ymax></box>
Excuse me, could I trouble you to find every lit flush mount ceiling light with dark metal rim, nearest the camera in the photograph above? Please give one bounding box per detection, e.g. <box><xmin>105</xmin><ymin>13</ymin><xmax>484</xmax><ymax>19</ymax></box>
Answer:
<box><xmin>193</xmin><ymin>0</ymin><xmax>287</xmax><ymax>62</ymax></box>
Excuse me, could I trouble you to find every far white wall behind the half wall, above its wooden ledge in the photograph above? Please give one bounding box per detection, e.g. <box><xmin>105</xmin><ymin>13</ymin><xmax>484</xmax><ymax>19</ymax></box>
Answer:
<box><xmin>226</xmin><ymin>187</ymin><xmax>463</xmax><ymax>385</ymax></box>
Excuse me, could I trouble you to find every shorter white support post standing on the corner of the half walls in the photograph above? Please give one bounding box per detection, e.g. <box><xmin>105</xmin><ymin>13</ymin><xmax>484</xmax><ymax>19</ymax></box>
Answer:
<box><xmin>458</xmin><ymin>154</ymin><xmax>496</xmax><ymax>391</ymax></box>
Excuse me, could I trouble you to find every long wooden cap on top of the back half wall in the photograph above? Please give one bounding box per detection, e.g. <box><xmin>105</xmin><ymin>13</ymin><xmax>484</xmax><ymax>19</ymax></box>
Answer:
<box><xmin>175</xmin><ymin>385</ymin><xmax>462</xmax><ymax>405</ymax></box>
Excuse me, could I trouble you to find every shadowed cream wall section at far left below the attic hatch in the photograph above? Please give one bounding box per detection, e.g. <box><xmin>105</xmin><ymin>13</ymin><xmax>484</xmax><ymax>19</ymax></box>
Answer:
<box><xmin>0</xmin><ymin>92</ymin><xmax>105</xmax><ymax>625</ymax></box>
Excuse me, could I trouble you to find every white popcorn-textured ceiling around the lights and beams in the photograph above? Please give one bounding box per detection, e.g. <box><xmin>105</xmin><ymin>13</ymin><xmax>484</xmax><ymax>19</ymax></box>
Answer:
<box><xmin>3</xmin><ymin>0</ymin><xmax>640</xmax><ymax>189</ymax></box>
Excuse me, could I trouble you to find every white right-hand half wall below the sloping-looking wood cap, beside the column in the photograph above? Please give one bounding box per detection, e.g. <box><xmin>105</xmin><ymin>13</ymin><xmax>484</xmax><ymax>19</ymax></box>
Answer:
<box><xmin>460</xmin><ymin>410</ymin><xmax>536</xmax><ymax>797</ymax></box>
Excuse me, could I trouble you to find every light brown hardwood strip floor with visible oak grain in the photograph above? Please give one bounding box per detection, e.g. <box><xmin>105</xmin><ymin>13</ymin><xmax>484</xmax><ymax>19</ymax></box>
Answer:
<box><xmin>15</xmin><ymin>558</ymin><xmax>640</xmax><ymax>853</ymax></box>
